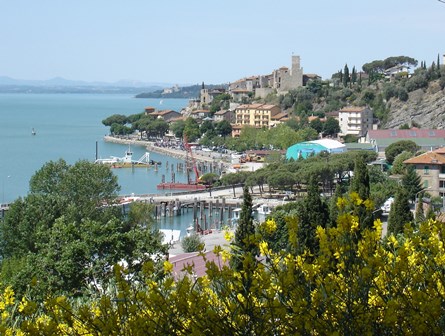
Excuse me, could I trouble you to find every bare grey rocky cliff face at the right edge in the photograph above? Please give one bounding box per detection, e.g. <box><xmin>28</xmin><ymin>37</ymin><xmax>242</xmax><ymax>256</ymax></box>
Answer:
<box><xmin>382</xmin><ymin>81</ymin><xmax>445</xmax><ymax>129</ymax></box>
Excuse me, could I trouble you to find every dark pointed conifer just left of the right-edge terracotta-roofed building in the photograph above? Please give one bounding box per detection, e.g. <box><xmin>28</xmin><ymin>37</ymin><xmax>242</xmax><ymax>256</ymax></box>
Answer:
<box><xmin>388</xmin><ymin>188</ymin><xmax>413</xmax><ymax>235</ymax></box>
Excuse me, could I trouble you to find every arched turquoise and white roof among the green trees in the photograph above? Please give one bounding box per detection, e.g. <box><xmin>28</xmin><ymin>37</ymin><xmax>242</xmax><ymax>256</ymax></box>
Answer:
<box><xmin>286</xmin><ymin>139</ymin><xmax>346</xmax><ymax>160</ymax></box>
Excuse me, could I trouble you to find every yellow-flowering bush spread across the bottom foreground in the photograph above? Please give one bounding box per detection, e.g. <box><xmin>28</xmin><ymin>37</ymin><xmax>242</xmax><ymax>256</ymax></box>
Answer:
<box><xmin>0</xmin><ymin>196</ymin><xmax>445</xmax><ymax>335</ymax></box>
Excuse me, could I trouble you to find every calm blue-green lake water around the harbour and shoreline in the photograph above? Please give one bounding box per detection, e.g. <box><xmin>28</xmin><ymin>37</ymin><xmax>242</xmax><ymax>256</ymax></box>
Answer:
<box><xmin>0</xmin><ymin>94</ymin><xmax>188</xmax><ymax>203</ymax></box>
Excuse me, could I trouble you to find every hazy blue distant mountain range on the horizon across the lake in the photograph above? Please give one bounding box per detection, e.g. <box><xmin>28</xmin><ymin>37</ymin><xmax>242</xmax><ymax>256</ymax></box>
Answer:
<box><xmin>0</xmin><ymin>76</ymin><xmax>173</xmax><ymax>93</ymax></box>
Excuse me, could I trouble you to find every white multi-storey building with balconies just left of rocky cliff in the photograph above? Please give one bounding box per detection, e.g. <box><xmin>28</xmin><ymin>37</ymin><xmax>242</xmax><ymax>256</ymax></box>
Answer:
<box><xmin>338</xmin><ymin>106</ymin><xmax>373</xmax><ymax>137</ymax></box>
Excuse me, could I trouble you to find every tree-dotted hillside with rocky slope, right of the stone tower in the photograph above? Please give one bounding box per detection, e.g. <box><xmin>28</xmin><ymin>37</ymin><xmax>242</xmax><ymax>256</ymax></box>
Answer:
<box><xmin>261</xmin><ymin>63</ymin><xmax>445</xmax><ymax>128</ymax></box>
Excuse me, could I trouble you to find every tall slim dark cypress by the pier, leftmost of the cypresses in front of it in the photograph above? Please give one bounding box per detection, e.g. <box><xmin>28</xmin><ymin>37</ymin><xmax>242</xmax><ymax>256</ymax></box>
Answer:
<box><xmin>232</xmin><ymin>185</ymin><xmax>258</xmax><ymax>270</ymax></box>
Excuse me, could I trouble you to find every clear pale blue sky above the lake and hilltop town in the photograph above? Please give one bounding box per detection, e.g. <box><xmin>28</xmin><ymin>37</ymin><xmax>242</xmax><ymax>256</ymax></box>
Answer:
<box><xmin>0</xmin><ymin>0</ymin><xmax>445</xmax><ymax>85</ymax></box>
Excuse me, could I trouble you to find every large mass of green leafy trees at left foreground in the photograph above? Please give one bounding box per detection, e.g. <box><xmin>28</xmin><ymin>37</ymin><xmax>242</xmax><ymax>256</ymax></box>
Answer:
<box><xmin>0</xmin><ymin>160</ymin><xmax>166</xmax><ymax>297</ymax></box>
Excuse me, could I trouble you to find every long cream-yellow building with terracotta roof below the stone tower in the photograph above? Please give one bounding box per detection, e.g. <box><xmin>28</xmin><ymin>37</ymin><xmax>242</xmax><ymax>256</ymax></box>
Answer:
<box><xmin>235</xmin><ymin>104</ymin><xmax>281</xmax><ymax>128</ymax></box>
